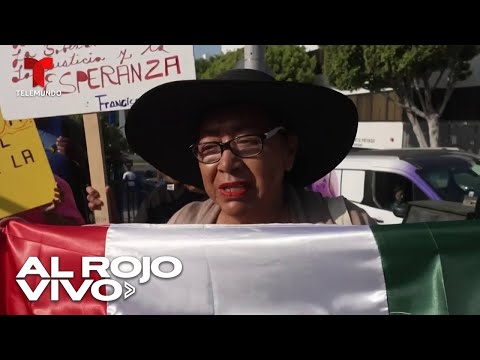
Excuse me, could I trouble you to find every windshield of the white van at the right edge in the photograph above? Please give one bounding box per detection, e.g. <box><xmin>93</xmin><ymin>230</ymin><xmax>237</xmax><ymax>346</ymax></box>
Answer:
<box><xmin>417</xmin><ymin>155</ymin><xmax>480</xmax><ymax>202</ymax></box>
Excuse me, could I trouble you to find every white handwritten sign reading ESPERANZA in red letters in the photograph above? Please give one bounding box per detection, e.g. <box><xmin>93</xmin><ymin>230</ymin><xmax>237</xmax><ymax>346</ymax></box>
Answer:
<box><xmin>0</xmin><ymin>45</ymin><xmax>195</xmax><ymax>120</ymax></box>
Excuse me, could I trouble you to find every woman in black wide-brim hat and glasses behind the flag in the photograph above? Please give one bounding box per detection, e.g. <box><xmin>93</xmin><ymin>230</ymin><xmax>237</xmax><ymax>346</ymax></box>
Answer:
<box><xmin>117</xmin><ymin>69</ymin><xmax>374</xmax><ymax>225</ymax></box>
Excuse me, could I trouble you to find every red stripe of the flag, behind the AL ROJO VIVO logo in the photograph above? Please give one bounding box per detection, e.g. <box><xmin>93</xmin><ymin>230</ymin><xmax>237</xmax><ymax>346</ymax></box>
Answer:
<box><xmin>0</xmin><ymin>220</ymin><xmax>108</xmax><ymax>315</ymax></box>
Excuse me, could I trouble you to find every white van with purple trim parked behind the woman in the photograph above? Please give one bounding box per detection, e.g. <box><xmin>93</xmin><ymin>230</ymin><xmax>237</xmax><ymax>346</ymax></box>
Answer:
<box><xmin>335</xmin><ymin>149</ymin><xmax>480</xmax><ymax>224</ymax></box>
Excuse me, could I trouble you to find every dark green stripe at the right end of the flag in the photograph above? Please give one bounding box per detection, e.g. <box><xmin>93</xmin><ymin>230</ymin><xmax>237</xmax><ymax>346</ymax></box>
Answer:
<box><xmin>372</xmin><ymin>220</ymin><xmax>480</xmax><ymax>314</ymax></box>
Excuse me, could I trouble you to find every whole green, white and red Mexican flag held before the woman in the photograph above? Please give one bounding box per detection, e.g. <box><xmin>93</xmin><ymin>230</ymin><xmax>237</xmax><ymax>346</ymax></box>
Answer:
<box><xmin>0</xmin><ymin>220</ymin><xmax>480</xmax><ymax>315</ymax></box>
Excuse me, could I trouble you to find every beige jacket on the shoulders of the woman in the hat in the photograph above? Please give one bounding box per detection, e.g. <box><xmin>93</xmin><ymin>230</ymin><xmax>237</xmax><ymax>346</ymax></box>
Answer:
<box><xmin>168</xmin><ymin>187</ymin><xmax>376</xmax><ymax>225</ymax></box>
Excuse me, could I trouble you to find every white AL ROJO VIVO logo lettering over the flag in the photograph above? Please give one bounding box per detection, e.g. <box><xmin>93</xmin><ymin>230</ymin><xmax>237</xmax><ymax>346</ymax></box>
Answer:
<box><xmin>16</xmin><ymin>256</ymin><xmax>183</xmax><ymax>301</ymax></box>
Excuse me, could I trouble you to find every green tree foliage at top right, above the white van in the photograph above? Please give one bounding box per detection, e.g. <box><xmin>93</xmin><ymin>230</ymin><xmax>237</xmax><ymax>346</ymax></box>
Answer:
<box><xmin>322</xmin><ymin>45</ymin><xmax>480</xmax><ymax>91</ymax></box>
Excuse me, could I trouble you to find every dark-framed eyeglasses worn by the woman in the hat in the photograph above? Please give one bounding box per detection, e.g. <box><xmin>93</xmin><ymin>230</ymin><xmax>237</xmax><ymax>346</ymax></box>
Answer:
<box><xmin>190</xmin><ymin>126</ymin><xmax>285</xmax><ymax>164</ymax></box>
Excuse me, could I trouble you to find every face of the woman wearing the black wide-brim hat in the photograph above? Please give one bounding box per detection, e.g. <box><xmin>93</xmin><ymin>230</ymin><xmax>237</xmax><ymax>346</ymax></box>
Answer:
<box><xmin>195</xmin><ymin>107</ymin><xmax>296</xmax><ymax>223</ymax></box>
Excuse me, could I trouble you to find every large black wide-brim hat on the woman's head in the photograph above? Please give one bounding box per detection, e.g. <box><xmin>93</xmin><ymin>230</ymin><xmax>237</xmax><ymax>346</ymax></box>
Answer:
<box><xmin>125</xmin><ymin>69</ymin><xmax>358</xmax><ymax>188</ymax></box>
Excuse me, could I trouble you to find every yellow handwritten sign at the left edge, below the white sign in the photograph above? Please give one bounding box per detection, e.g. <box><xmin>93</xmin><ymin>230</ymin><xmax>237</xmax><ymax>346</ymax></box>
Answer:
<box><xmin>0</xmin><ymin>112</ymin><xmax>55</xmax><ymax>218</ymax></box>
